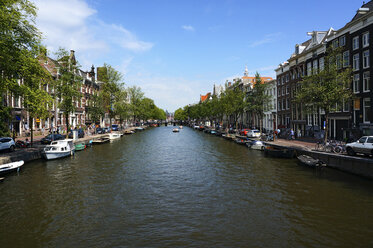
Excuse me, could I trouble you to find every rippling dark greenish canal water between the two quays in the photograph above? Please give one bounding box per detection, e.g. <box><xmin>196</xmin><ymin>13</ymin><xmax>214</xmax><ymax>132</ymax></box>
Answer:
<box><xmin>0</xmin><ymin>127</ymin><xmax>373</xmax><ymax>248</ymax></box>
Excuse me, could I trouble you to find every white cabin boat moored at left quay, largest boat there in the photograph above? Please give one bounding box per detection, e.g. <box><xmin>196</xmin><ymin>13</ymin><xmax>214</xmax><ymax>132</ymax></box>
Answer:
<box><xmin>43</xmin><ymin>139</ymin><xmax>75</xmax><ymax>160</ymax></box>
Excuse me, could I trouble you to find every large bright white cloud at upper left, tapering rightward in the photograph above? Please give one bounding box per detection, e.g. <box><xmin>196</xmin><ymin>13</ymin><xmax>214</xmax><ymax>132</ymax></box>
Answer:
<box><xmin>35</xmin><ymin>0</ymin><xmax>153</xmax><ymax>66</ymax></box>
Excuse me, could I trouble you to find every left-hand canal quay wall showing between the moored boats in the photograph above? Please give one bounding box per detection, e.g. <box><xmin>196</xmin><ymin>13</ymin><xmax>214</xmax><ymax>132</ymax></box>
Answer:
<box><xmin>0</xmin><ymin>127</ymin><xmax>136</xmax><ymax>165</ymax></box>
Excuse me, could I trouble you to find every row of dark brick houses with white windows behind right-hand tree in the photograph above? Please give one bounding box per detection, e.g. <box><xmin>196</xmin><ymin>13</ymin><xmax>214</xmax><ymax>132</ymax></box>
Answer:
<box><xmin>275</xmin><ymin>2</ymin><xmax>373</xmax><ymax>140</ymax></box>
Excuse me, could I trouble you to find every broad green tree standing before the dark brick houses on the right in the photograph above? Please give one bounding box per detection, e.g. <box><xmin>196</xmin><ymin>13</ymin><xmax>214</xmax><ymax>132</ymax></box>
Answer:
<box><xmin>295</xmin><ymin>48</ymin><xmax>353</xmax><ymax>142</ymax></box>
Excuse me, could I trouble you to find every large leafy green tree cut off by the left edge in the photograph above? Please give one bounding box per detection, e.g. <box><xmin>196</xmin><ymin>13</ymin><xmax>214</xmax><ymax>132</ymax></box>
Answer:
<box><xmin>0</xmin><ymin>0</ymin><xmax>41</xmax><ymax>135</ymax></box>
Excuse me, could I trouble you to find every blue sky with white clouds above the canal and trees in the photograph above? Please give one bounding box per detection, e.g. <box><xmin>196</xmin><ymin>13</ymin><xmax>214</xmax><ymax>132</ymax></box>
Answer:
<box><xmin>35</xmin><ymin>0</ymin><xmax>362</xmax><ymax>111</ymax></box>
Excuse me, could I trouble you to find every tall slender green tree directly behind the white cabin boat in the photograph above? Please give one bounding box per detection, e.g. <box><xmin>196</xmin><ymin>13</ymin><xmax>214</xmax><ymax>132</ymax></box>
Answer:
<box><xmin>55</xmin><ymin>48</ymin><xmax>82</xmax><ymax>135</ymax></box>
